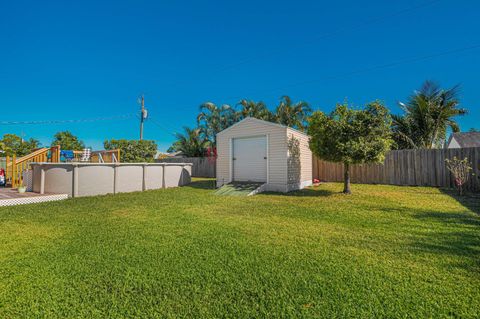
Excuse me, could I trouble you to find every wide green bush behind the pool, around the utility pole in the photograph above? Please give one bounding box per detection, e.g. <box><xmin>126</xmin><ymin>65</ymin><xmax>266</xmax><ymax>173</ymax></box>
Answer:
<box><xmin>103</xmin><ymin>139</ymin><xmax>157</xmax><ymax>163</ymax></box>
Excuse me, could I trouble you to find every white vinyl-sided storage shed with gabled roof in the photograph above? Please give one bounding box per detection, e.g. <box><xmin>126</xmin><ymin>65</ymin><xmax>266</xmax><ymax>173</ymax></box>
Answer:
<box><xmin>216</xmin><ymin>117</ymin><xmax>312</xmax><ymax>192</ymax></box>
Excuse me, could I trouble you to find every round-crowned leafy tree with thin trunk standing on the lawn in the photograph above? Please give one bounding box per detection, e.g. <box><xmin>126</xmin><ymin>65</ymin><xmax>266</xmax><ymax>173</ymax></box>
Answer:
<box><xmin>308</xmin><ymin>101</ymin><xmax>392</xmax><ymax>194</ymax></box>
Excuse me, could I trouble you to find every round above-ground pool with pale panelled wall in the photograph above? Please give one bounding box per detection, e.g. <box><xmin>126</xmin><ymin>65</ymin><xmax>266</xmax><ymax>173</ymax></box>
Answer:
<box><xmin>31</xmin><ymin>163</ymin><xmax>192</xmax><ymax>197</ymax></box>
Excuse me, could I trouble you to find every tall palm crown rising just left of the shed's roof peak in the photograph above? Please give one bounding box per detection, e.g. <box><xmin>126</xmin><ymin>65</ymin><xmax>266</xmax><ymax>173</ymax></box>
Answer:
<box><xmin>197</xmin><ymin>102</ymin><xmax>237</xmax><ymax>145</ymax></box>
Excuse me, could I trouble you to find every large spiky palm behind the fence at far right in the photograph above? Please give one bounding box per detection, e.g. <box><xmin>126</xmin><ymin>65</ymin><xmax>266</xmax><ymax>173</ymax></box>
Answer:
<box><xmin>392</xmin><ymin>81</ymin><xmax>467</xmax><ymax>149</ymax></box>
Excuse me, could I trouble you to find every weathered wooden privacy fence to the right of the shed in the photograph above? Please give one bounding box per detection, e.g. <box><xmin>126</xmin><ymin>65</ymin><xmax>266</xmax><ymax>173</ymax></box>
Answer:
<box><xmin>312</xmin><ymin>147</ymin><xmax>480</xmax><ymax>191</ymax></box>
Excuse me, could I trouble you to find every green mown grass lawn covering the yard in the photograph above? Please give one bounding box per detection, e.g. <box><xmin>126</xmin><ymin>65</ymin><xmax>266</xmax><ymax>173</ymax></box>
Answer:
<box><xmin>0</xmin><ymin>181</ymin><xmax>480</xmax><ymax>318</ymax></box>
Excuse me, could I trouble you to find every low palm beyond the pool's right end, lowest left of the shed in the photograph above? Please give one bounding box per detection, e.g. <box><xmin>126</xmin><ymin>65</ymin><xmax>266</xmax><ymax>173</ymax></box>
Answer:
<box><xmin>168</xmin><ymin>127</ymin><xmax>210</xmax><ymax>157</ymax></box>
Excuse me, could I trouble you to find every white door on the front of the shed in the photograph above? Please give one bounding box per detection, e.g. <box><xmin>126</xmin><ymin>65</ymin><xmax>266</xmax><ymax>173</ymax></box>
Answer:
<box><xmin>233</xmin><ymin>136</ymin><xmax>267</xmax><ymax>183</ymax></box>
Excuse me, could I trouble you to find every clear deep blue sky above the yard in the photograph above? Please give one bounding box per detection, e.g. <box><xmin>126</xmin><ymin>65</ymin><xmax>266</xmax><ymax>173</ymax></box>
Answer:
<box><xmin>0</xmin><ymin>0</ymin><xmax>480</xmax><ymax>150</ymax></box>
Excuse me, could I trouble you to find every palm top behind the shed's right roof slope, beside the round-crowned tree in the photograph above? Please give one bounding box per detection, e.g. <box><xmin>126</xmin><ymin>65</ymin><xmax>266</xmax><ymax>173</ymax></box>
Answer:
<box><xmin>275</xmin><ymin>95</ymin><xmax>312</xmax><ymax>131</ymax></box>
